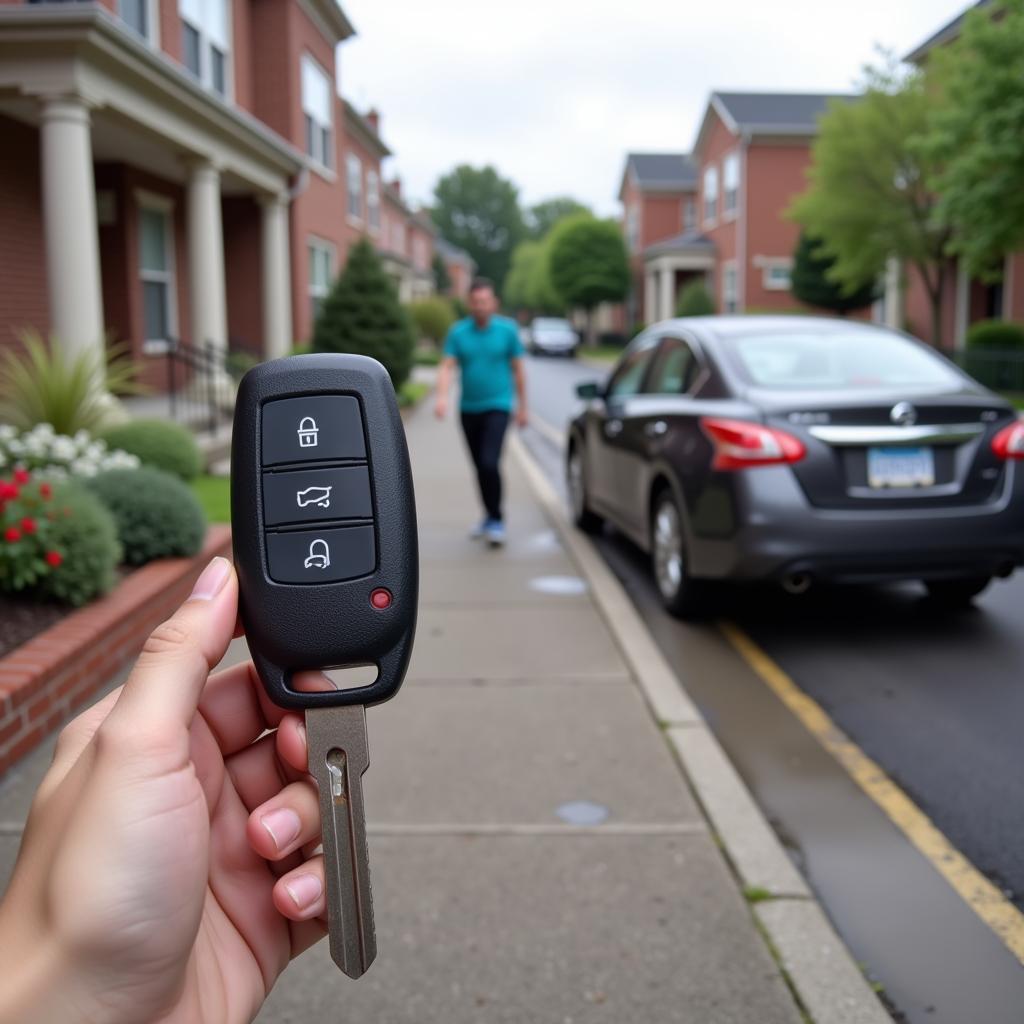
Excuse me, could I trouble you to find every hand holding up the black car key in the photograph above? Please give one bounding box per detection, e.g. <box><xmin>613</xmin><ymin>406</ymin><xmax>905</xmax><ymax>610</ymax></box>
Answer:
<box><xmin>0</xmin><ymin>558</ymin><xmax>326</xmax><ymax>1024</ymax></box>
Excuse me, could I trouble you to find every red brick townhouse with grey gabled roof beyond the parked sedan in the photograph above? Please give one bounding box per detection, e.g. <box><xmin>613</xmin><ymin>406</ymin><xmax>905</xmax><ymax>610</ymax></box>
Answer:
<box><xmin>621</xmin><ymin>92</ymin><xmax>848</xmax><ymax>323</ymax></box>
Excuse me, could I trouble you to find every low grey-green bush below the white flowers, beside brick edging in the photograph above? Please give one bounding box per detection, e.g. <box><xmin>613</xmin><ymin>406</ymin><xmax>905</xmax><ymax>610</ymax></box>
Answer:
<box><xmin>88</xmin><ymin>467</ymin><xmax>206</xmax><ymax>565</ymax></box>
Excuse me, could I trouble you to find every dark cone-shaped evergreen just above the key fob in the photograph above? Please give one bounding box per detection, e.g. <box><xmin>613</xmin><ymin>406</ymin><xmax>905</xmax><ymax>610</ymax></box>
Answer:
<box><xmin>312</xmin><ymin>239</ymin><xmax>415</xmax><ymax>390</ymax></box>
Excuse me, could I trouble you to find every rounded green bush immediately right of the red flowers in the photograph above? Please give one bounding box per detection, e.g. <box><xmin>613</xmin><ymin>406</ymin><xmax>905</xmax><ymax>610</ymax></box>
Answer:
<box><xmin>35</xmin><ymin>481</ymin><xmax>120</xmax><ymax>605</ymax></box>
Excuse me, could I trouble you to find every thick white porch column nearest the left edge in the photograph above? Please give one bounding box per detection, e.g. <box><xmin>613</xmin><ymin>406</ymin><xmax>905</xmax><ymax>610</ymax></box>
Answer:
<box><xmin>40</xmin><ymin>96</ymin><xmax>103</xmax><ymax>367</ymax></box>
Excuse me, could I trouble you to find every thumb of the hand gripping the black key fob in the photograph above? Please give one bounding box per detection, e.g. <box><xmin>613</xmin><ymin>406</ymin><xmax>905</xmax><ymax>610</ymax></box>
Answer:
<box><xmin>108</xmin><ymin>557</ymin><xmax>239</xmax><ymax>739</ymax></box>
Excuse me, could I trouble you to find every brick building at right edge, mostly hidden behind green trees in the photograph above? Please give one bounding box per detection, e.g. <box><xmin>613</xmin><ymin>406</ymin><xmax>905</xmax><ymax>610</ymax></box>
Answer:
<box><xmin>890</xmin><ymin>0</ymin><xmax>1024</xmax><ymax>349</ymax></box>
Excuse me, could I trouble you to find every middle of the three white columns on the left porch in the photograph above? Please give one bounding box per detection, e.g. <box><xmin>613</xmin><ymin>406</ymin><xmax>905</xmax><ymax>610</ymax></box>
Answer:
<box><xmin>188</xmin><ymin>162</ymin><xmax>227</xmax><ymax>360</ymax></box>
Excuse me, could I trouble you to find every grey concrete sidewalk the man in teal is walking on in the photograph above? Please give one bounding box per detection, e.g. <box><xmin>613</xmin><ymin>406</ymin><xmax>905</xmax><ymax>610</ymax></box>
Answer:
<box><xmin>0</xmin><ymin>395</ymin><xmax>887</xmax><ymax>1024</ymax></box>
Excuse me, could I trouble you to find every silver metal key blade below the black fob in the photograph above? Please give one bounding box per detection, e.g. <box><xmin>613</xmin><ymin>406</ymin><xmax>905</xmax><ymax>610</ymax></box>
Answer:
<box><xmin>306</xmin><ymin>705</ymin><xmax>377</xmax><ymax>978</ymax></box>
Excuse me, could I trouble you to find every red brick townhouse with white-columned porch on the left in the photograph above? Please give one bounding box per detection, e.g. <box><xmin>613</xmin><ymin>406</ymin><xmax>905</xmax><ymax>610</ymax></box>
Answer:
<box><xmin>0</xmin><ymin>0</ymin><xmax>432</xmax><ymax>385</ymax></box>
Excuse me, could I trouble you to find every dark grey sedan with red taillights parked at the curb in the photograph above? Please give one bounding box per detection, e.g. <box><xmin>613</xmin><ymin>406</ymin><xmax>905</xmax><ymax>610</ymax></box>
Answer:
<box><xmin>566</xmin><ymin>316</ymin><xmax>1024</xmax><ymax>615</ymax></box>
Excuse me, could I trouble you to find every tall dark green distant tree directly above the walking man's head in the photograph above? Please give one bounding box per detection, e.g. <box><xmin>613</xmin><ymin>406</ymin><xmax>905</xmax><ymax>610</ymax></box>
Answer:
<box><xmin>431</xmin><ymin>164</ymin><xmax>524</xmax><ymax>288</ymax></box>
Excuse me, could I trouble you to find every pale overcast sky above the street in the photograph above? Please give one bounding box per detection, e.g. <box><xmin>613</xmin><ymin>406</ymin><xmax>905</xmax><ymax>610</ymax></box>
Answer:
<box><xmin>339</xmin><ymin>0</ymin><xmax>968</xmax><ymax>214</ymax></box>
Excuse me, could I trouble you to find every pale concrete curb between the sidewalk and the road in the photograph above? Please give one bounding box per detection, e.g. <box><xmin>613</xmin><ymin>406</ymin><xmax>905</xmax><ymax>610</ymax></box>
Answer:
<box><xmin>509</xmin><ymin>434</ymin><xmax>892</xmax><ymax>1024</ymax></box>
